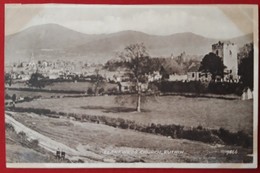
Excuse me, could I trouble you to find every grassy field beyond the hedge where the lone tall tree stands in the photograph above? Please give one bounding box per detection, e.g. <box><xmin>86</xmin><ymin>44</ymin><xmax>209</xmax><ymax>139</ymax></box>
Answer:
<box><xmin>17</xmin><ymin>96</ymin><xmax>253</xmax><ymax>134</ymax></box>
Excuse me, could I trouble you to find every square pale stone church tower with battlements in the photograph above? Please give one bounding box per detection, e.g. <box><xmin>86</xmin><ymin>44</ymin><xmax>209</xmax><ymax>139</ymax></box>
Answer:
<box><xmin>212</xmin><ymin>41</ymin><xmax>238</xmax><ymax>79</ymax></box>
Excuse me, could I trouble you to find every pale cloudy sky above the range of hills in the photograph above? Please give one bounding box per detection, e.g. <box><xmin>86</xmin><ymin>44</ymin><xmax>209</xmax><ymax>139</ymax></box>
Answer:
<box><xmin>5</xmin><ymin>4</ymin><xmax>254</xmax><ymax>39</ymax></box>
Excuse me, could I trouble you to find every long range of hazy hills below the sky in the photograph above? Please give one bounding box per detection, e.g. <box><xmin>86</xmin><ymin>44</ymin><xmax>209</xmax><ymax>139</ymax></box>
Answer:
<box><xmin>5</xmin><ymin>24</ymin><xmax>252</xmax><ymax>63</ymax></box>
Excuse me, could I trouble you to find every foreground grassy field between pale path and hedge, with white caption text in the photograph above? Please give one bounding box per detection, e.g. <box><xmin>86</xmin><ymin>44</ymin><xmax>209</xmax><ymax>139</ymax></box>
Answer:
<box><xmin>11</xmin><ymin>113</ymin><xmax>251</xmax><ymax>163</ymax></box>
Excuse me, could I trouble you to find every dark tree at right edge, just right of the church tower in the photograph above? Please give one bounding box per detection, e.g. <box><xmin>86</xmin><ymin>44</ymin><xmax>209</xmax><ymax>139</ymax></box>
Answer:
<box><xmin>238</xmin><ymin>49</ymin><xmax>254</xmax><ymax>90</ymax></box>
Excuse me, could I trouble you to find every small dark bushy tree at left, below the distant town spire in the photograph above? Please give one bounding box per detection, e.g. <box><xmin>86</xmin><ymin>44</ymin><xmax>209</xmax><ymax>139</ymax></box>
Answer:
<box><xmin>27</xmin><ymin>72</ymin><xmax>47</xmax><ymax>88</ymax></box>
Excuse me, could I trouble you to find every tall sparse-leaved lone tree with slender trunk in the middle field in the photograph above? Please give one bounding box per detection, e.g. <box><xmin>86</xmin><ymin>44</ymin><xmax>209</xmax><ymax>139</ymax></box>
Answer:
<box><xmin>120</xmin><ymin>43</ymin><xmax>157</xmax><ymax>112</ymax></box>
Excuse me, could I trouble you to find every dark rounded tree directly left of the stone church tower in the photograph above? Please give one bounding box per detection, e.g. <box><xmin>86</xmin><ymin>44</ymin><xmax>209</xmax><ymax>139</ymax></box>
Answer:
<box><xmin>199</xmin><ymin>52</ymin><xmax>225</xmax><ymax>80</ymax></box>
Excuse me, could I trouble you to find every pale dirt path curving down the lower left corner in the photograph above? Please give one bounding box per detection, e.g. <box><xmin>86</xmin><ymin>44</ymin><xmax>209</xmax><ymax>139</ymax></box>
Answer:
<box><xmin>5</xmin><ymin>112</ymin><xmax>105</xmax><ymax>162</ymax></box>
